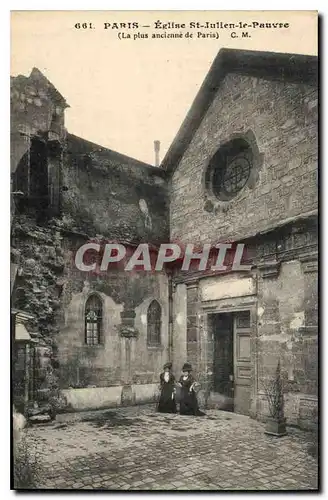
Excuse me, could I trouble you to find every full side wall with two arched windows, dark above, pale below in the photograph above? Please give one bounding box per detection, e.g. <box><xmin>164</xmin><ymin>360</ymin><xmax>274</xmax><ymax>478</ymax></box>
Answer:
<box><xmin>53</xmin><ymin>134</ymin><xmax>169</xmax><ymax>407</ymax></box>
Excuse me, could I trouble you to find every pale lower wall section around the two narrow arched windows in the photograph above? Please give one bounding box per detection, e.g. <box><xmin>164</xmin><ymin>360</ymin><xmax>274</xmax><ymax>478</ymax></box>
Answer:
<box><xmin>56</xmin><ymin>233</ymin><xmax>169</xmax><ymax>394</ymax></box>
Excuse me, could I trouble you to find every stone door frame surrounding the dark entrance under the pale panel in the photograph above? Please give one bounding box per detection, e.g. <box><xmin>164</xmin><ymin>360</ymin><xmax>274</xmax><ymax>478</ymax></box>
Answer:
<box><xmin>200</xmin><ymin>296</ymin><xmax>258</xmax><ymax>418</ymax></box>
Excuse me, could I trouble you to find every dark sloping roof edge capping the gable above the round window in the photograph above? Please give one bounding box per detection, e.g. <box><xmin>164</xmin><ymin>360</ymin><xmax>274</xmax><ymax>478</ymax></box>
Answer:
<box><xmin>161</xmin><ymin>49</ymin><xmax>318</xmax><ymax>174</ymax></box>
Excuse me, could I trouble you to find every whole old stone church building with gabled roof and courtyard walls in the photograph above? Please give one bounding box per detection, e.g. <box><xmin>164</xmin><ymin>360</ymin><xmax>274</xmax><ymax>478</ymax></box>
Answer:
<box><xmin>11</xmin><ymin>49</ymin><xmax>318</xmax><ymax>427</ymax></box>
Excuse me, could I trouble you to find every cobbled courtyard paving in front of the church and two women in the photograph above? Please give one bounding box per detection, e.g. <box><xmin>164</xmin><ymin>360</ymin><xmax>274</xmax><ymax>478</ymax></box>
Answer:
<box><xmin>20</xmin><ymin>406</ymin><xmax>317</xmax><ymax>490</ymax></box>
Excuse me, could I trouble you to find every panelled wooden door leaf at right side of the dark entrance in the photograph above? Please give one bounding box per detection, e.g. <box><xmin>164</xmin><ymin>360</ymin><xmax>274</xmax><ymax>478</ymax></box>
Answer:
<box><xmin>234</xmin><ymin>311</ymin><xmax>251</xmax><ymax>415</ymax></box>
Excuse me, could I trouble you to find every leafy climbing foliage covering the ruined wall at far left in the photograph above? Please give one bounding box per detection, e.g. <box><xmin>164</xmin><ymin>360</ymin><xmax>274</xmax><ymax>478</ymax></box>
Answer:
<box><xmin>11</xmin><ymin>215</ymin><xmax>64</xmax><ymax>411</ymax></box>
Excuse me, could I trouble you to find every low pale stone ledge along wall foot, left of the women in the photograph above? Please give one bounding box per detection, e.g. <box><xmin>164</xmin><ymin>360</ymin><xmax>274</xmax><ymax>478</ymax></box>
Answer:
<box><xmin>62</xmin><ymin>384</ymin><xmax>157</xmax><ymax>411</ymax></box>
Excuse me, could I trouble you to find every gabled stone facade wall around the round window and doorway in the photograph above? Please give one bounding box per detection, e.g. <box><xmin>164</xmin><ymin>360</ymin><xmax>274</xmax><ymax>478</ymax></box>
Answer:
<box><xmin>170</xmin><ymin>68</ymin><xmax>318</xmax><ymax>426</ymax></box>
